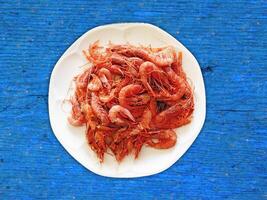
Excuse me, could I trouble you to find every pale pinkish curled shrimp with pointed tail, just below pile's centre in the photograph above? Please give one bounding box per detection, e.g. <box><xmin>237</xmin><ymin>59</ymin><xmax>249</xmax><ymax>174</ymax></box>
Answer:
<box><xmin>108</xmin><ymin>105</ymin><xmax>135</xmax><ymax>126</ymax></box>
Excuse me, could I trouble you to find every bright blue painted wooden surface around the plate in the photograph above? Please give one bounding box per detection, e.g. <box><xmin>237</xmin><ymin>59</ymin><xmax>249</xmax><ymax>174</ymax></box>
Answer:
<box><xmin>0</xmin><ymin>0</ymin><xmax>267</xmax><ymax>200</ymax></box>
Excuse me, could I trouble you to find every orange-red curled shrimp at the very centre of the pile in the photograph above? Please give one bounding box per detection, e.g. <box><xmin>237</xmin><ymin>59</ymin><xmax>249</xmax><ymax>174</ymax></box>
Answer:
<box><xmin>119</xmin><ymin>84</ymin><xmax>150</xmax><ymax>109</ymax></box>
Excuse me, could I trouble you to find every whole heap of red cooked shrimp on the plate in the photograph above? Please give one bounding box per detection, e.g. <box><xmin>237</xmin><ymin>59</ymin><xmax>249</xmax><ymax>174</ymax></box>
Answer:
<box><xmin>68</xmin><ymin>41</ymin><xmax>194</xmax><ymax>162</ymax></box>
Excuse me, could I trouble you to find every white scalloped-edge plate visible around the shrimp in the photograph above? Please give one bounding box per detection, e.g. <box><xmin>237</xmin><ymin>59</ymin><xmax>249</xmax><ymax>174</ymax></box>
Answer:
<box><xmin>48</xmin><ymin>23</ymin><xmax>206</xmax><ymax>178</ymax></box>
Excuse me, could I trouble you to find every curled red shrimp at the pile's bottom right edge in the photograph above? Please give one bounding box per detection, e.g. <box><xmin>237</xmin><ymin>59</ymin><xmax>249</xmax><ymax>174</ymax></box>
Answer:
<box><xmin>146</xmin><ymin>129</ymin><xmax>177</xmax><ymax>149</ymax></box>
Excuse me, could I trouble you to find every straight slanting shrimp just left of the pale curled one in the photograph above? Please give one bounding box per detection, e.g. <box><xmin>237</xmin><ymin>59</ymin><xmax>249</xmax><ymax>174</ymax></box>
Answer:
<box><xmin>91</xmin><ymin>92</ymin><xmax>109</xmax><ymax>125</ymax></box>
